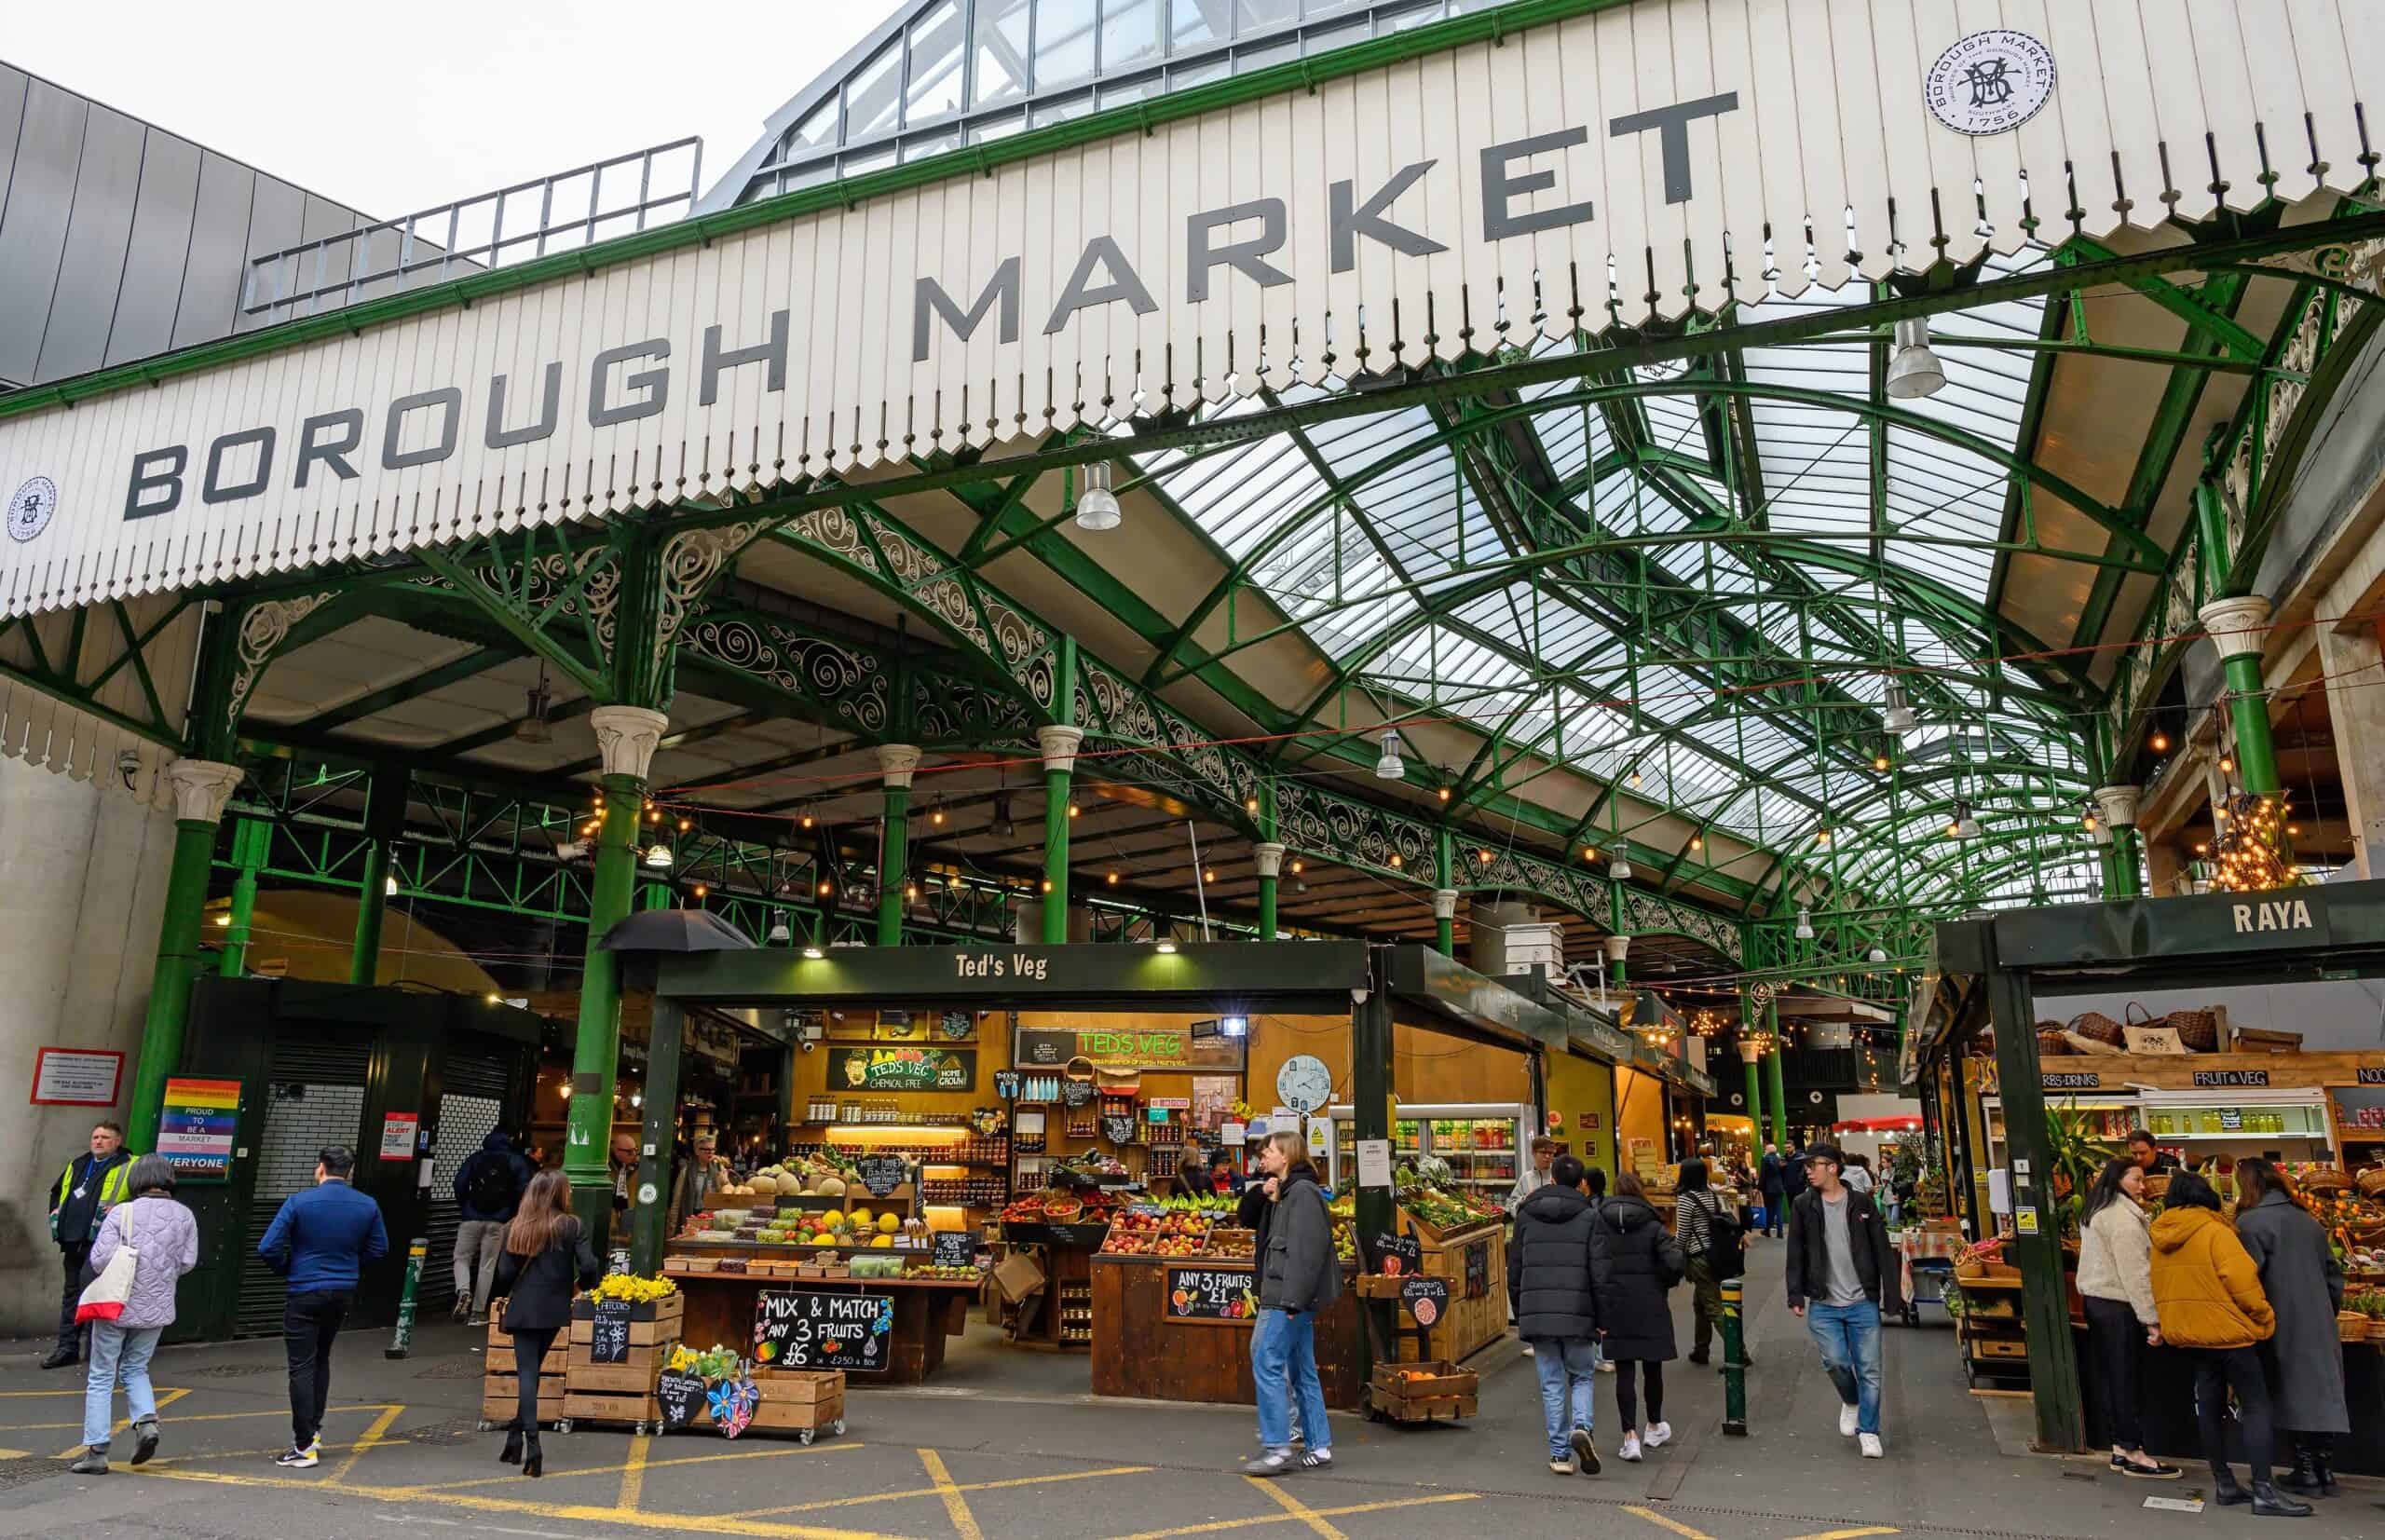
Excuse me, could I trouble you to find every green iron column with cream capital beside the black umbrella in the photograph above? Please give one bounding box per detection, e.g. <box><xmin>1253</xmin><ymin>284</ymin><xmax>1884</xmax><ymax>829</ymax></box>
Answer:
<box><xmin>563</xmin><ymin>705</ymin><xmax>670</xmax><ymax>1251</ymax></box>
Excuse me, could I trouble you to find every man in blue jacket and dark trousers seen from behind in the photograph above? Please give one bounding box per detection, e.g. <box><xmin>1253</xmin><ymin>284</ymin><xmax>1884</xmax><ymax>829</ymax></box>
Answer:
<box><xmin>257</xmin><ymin>1144</ymin><xmax>388</xmax><ymax>1468</ymax></box>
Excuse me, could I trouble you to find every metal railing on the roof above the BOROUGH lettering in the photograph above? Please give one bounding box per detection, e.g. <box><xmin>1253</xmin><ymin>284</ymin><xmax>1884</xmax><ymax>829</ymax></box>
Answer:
<box><xmin>241</xmin><ymin>138</ymin><xmax>703</xmax><ymax>321</ymax></box>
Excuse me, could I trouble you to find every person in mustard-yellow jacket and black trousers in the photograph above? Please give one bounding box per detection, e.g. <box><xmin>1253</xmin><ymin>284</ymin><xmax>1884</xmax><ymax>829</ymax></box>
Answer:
<box><xmin>2154</xmin><ymin>1173</ymin><xmax>2311</xmax><ymax>1519</ymax></box>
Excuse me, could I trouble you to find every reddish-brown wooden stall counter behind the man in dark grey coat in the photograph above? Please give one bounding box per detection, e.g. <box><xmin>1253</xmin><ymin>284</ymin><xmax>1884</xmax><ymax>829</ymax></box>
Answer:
<box><xmin>1092</xmin><ymin>1257</ymin><xmax>1364</xmax><ymax>1411</ymax></box>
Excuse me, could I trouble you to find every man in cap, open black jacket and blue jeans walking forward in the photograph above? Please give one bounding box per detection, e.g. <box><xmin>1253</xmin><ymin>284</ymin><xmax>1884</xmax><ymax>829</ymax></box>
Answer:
<box><xmin>1786</xmin><ymin>1144</ymin><xmax>1896</xmax><ymax>1459</ymax></box>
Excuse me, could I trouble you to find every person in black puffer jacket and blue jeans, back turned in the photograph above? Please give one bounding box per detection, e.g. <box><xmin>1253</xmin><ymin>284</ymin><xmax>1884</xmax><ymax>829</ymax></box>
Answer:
<box><xmin>1507</xmin><ymin>1153</ymin><xmax>1598</xmax><ymax>1476</ymax></box>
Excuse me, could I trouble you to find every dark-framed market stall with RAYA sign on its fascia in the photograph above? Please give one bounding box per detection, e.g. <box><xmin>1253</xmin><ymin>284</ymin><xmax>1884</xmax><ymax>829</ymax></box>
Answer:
<box><xmin>1903</xmin><ymin>882</ymin><xmax>2385</xmax><ymax>1473</ymax></box>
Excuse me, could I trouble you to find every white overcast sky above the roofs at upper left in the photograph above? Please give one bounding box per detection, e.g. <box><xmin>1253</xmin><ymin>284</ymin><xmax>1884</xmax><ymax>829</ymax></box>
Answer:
<box><xmin>0</xmin><ymin>0</ymin><xmax>897</xmax><ymax>219</ymax></box>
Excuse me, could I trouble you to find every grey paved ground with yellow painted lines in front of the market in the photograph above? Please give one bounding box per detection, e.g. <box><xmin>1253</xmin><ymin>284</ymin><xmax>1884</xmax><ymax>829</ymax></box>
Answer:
<box><xmin>0</xmin><ymin>1247</ymin><xmax>2385</xmax><ymax>1540</ymax></box>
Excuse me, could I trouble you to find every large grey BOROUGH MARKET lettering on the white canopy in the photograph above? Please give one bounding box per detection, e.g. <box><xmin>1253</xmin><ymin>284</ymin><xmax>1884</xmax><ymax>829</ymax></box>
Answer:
<box><xmin>124</xmin><ymin>90</ymin><xmax>1738</xmax><ymax>531</ymax></box>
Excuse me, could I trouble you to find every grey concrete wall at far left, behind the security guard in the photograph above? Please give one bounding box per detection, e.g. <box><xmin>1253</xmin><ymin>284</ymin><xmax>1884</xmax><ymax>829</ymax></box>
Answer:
<box><xmin>0</xmin><ymin>758</ymin><xmax>174</xmax><ymax>1338</ymax></box>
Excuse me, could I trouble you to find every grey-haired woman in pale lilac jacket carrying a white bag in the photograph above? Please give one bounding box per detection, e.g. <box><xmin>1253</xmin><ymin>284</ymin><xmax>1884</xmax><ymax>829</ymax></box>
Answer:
<box><xmin>72</xmin><ymin>1153</ymin><xmax>198</xmax><ymax>1476</ymax></box>
